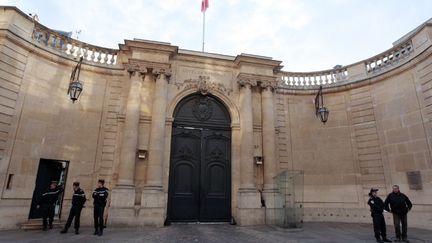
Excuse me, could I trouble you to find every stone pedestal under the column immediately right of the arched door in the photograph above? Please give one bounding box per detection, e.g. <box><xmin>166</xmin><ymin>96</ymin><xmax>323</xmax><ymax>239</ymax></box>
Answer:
<box><xmin>236</xmin><ymin>188</ymin><xmax>265</xmax><ymax>226</ymax></box>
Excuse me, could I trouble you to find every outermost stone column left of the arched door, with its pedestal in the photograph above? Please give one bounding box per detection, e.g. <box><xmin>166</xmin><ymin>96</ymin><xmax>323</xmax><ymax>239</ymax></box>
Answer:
<box><xmin>111</xmin><ymin>71</ymin><xmax>142</xmax><ymax>207</ymax></box>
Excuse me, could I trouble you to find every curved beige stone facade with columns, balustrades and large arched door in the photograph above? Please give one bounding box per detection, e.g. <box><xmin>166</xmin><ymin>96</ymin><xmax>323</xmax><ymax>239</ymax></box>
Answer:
<box><xmin>0</xmin><ymin>7</ymin><xmax>432</xmax><ymax>229</ymax></box>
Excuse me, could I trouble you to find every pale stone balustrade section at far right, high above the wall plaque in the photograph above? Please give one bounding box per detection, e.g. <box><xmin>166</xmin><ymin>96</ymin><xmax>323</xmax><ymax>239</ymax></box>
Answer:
<box><xmin>365</xmin><ymin>40</ymin><xmax>413</xmax><ymax>73</ymax></box>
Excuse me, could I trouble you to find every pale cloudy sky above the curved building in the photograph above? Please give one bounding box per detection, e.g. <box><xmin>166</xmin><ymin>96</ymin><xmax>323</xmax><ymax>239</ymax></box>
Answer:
<box><xmin>0</xmin><ymin>0</ymin><xmax>432</xmax><ymax>72</ymax></box>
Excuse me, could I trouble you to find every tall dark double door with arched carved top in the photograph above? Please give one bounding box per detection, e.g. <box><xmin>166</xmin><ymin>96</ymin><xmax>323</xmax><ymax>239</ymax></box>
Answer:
<box><xmin>167</xmin><ymin>94</ymin><xmax>231</xmax><ymax>222</ymax></box>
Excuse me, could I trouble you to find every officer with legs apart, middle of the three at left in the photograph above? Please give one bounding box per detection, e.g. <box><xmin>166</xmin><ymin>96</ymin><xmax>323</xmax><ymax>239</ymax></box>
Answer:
<box><xmin>60</xmin><ymin>182</ymin><xmax>86</xmax><ymax>234</ymax></box>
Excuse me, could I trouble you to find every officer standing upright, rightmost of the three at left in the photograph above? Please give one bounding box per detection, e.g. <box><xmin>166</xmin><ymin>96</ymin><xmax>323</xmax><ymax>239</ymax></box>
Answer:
<box><xmin>92</xmin><ymin>180</ymin><xmax>109</xmax><ymax>236</ymax></box>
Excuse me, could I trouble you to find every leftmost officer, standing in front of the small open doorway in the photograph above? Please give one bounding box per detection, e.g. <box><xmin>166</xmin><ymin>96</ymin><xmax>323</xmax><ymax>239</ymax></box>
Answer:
<box><xmin>37</xmin><ymin>181</ymin><xmax>63</xmax><ymax>230</ymax></box>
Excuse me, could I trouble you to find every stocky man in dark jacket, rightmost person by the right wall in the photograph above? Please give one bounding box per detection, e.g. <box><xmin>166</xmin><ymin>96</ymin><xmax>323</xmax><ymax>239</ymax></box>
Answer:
<box><xmin>384</xmin><ymin>185</ymin><xmax>412</xmax><ymax>242</ymax></box>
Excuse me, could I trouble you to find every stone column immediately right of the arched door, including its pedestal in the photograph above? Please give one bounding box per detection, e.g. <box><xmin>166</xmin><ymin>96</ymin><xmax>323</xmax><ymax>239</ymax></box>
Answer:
<box><xmin>236</xmin><ymin>80</ymin><xmax>264</xmax><ymax>225</ymax></box>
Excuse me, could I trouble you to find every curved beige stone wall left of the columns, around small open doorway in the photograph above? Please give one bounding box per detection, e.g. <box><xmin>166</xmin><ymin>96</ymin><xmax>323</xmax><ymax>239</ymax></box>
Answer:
<box><xmin>0</xmin><ymin>8</ymin><xmax>125</xmax><ymax>228</ymax></box>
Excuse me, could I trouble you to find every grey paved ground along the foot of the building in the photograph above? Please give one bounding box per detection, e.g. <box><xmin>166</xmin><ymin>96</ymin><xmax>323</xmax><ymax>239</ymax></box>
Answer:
<box><xmin>0</xmin><ymin>223</ymin><xmax>432</xmax><ymax>243</ymax></box>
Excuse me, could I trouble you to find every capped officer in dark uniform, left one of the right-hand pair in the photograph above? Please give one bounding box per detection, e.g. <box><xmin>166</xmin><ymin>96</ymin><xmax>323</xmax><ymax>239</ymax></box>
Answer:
<box><xmin>368</xmin><ymin>188</ymin><xmax>392</xmax><ymax>242</ymax></box>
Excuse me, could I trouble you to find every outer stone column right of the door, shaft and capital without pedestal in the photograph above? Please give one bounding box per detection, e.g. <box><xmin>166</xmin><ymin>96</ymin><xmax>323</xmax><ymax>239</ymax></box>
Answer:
<box><xmin>261</xmin><ymin>83</ymin><xmax>277</xmax><ymax>190</ymax></box>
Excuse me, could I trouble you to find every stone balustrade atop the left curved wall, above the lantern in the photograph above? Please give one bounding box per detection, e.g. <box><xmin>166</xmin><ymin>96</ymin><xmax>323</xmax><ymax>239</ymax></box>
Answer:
<box><xmin>32</xmin><ymin>22</ymin><xmax>118</xmax><ymax>66</ymax></box>
